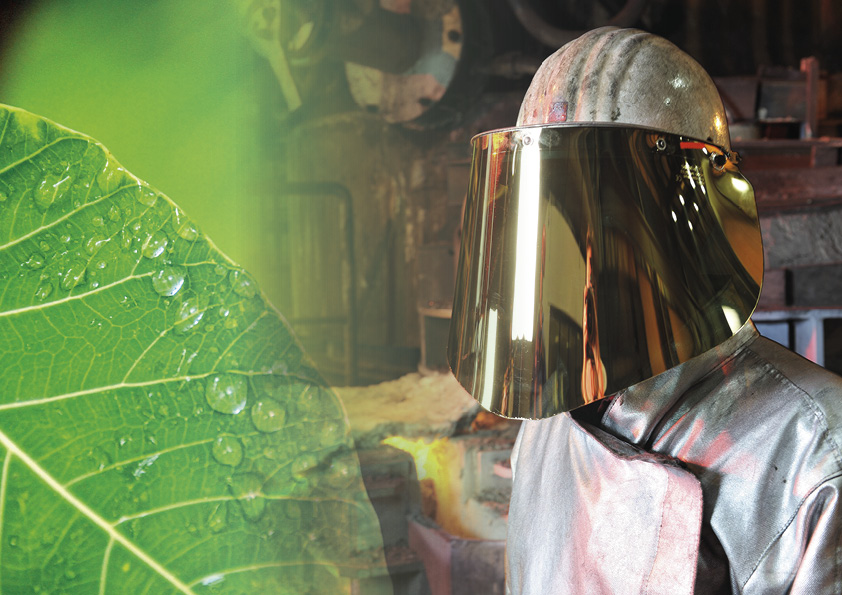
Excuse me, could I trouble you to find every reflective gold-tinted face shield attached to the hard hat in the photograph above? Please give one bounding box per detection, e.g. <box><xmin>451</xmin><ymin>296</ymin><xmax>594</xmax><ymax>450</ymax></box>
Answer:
<box><xmin>448</xmin><ymin>124</ymin><xmax>763</xmax><ymax>419</ymax></box>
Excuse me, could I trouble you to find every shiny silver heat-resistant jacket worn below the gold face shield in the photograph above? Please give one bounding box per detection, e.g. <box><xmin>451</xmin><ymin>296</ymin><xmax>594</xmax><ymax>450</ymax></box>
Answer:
<box><xmin>507</xmin><ymin>322</ymin><xmax>842</xmax><ymax>595</ymax></box>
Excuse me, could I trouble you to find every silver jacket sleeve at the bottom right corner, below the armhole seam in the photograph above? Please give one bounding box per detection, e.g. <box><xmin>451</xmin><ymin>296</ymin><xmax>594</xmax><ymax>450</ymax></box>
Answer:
<box><xmin>742</xmin><ymin>474</ymin><xmax>842</xmax><ymax>595</ymax></box>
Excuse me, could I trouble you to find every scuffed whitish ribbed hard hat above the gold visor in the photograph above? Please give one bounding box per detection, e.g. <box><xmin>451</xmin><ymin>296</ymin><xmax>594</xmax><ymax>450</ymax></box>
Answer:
<box><xmin>518</xmin><ymin>27</ymin><xmax>731</xmax><ymax>151</ymax></box>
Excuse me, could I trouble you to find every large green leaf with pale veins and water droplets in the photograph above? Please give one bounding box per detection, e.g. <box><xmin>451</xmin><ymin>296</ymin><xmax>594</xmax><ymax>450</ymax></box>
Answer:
<box><xmin>0</xmin><ymin>107</ymin><xmax>383</xmax><ymax>594</ymax></box>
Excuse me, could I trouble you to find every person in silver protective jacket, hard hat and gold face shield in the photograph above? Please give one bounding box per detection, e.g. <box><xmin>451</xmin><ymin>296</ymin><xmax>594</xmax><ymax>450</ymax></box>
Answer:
<box><xmin>449</xmin><ymin>28</ymin><xmax>842</xmax><ymax>595</ymax></box>
